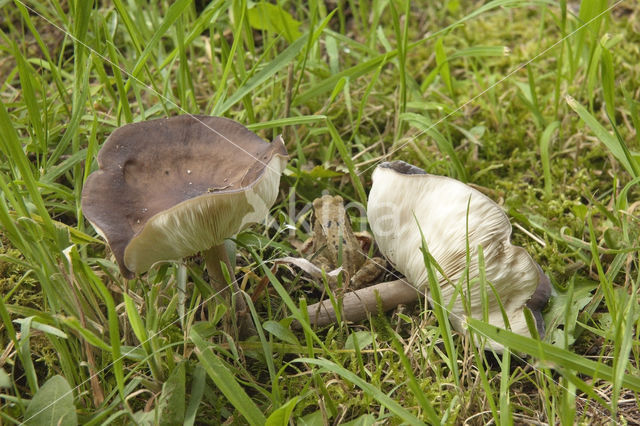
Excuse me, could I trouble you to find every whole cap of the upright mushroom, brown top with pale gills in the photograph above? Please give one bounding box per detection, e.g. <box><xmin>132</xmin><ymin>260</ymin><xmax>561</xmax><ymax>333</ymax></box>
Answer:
<box><xmin>82</xmin><ymin>115</ymin><xmax>287</xmax><ymax>278</ymax></box>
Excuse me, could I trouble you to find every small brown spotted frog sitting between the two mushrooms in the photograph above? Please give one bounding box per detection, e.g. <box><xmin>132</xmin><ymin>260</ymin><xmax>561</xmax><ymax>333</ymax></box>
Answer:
<box><xmin>311</xmin><ymin>195</ymin><xmax>386</xmax><ymax>290</ymax></box>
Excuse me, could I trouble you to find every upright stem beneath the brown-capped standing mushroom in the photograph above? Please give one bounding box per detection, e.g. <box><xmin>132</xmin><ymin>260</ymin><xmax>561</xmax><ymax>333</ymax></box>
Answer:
<box><xmin>203</xmin><ymin>243</ymin><xmax>251</xmax><ymax>334</ymax></box>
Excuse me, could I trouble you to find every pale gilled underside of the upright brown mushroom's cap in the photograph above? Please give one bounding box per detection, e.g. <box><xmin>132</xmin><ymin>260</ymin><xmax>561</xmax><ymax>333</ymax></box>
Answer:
<box><xmin>124</xmin><ymin>155</ymin><xmax>286</xmax><ymax>273</ymax></box>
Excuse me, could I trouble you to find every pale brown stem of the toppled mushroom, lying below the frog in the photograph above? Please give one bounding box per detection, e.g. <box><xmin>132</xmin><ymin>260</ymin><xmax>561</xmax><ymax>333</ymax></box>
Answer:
<box><xmin>307</xmin><ymin>280</ymin><xmax>421</xmax><ymax>327</ymax></box>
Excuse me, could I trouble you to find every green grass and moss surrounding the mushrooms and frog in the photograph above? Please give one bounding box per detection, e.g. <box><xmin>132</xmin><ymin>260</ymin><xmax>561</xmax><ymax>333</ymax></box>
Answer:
<box><xmin>0</xmin><ymin>0</ymin><xmax>640</xmax><ymax>425</ymax></box>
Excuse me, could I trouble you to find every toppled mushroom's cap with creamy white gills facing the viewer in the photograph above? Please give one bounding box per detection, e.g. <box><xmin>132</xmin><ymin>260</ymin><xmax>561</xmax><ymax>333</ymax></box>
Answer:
<box><xmin>367</xmin><ymin>161</ymin><xmax>551</xmax><ymax>350</ymax></box>
